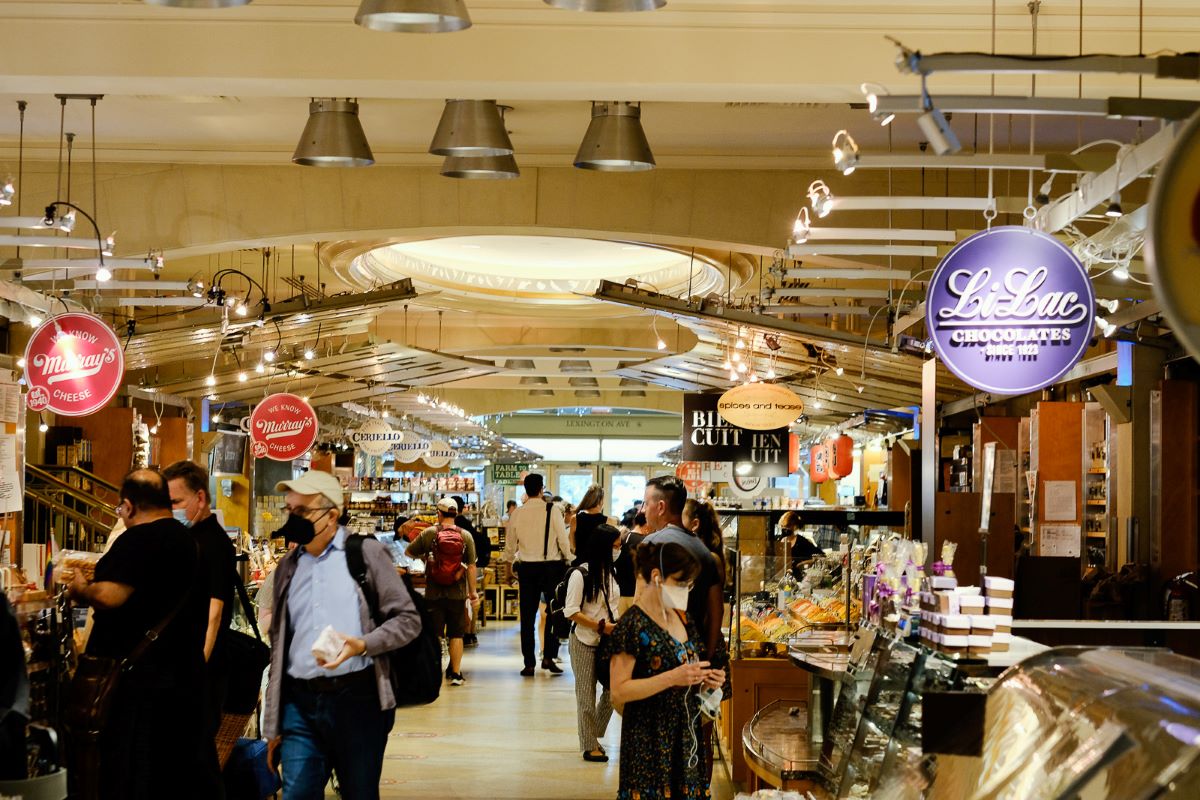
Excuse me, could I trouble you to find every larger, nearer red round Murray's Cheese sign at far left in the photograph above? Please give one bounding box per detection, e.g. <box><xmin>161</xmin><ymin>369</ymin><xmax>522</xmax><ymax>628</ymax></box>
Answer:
<box><xmin>25</xmin><ymin>312</ymin><xmax>125</xmax><ymax>416</ymax></box>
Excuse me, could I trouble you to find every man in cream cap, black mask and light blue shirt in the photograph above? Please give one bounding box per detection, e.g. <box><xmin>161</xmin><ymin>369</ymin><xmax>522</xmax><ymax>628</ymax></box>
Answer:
<box><xmin>263</xmin><ymin>470</ymin><xmax>421</xmax><ymax>800</ymax></box>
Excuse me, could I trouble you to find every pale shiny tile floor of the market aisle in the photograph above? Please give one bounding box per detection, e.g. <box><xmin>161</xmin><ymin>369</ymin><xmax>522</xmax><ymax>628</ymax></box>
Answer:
<box><xmin>360</xmin><ymin>622</ymin><xmax>734</xmax><ymax>800</ymax></box>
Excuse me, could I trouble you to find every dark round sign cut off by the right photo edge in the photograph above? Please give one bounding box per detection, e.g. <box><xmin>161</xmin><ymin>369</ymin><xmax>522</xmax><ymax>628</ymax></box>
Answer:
<box><xmin>1146</xmin><ymin>108</ymin><xmax>1200</xmax><ymax>361</ymax></box>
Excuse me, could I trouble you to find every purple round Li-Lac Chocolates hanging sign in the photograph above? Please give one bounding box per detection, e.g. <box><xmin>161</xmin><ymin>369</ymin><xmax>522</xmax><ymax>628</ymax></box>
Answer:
<box><xmin>925</xmin><ymin>225</ymin><xmax>1096</xmax><ymax>395</ymax></box>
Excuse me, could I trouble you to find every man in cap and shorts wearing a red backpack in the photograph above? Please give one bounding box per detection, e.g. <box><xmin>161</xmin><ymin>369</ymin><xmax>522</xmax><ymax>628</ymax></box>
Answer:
<box><xmin>407</xmin><ymin>498</ymin><xmax>479</xmax><ymax>686</ymax></box>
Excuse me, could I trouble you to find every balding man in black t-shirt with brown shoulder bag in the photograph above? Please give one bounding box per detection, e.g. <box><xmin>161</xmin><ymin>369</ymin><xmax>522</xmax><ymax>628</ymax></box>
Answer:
<box><xmin>71</xmin><ymin>469</ymin><xmax>212</xmax><ymax>800</ymax></box>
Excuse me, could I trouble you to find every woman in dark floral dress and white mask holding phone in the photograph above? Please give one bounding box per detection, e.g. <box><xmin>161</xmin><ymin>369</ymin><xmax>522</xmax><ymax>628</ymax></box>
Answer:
<box><xmin>608</xmin><ymin>542</ymin><xmax>725</xmax><ymax>800</ymax></box>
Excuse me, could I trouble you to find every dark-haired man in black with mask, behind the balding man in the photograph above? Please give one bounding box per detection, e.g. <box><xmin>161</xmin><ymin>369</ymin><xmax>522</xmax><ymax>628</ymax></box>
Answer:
<box><xmin>162</xmin><ymin>461</ymin><xmax>240</xmax><ymax>767</ymax></box>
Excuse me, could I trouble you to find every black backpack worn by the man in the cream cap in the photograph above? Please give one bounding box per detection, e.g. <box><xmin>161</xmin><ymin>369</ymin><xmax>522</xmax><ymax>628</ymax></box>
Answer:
<box><xmin>346</xmin><ymin>535</ymin><xmax>442</xmax><ymax>708</ymax></box>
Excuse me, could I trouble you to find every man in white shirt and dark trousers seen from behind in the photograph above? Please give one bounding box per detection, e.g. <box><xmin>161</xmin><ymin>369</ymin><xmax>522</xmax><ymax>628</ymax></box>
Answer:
<box><xmin>504</xmin><ymin>473</ymin><xmax>575</xmax><ymax>678</ymax></box>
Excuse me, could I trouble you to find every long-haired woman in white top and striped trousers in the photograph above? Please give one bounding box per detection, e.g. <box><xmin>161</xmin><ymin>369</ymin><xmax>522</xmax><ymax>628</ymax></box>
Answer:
<box><xmin>563</xmin><ymin>525</ymin><xmax>620</xmax><ymax>762</ymax></box>
